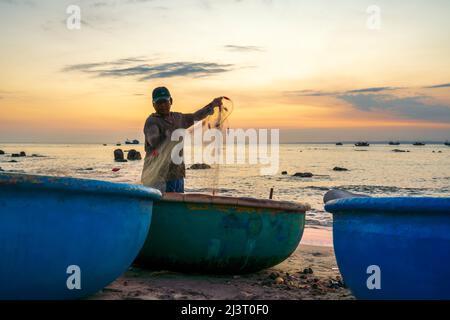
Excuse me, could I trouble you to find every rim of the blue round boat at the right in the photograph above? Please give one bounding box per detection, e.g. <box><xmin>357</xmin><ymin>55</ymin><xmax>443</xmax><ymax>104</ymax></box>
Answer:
<box><xmin>325</xmin><ymin>197</ymin><xmax>450</xmax><ymax>214</ymax></box>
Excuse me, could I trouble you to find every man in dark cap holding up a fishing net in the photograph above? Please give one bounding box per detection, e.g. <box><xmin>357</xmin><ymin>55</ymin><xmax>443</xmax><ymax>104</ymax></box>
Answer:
<box><xmin>142</xmin><ymin>87</ymin><xmax>223</xmax><ymax>193</ymax></box>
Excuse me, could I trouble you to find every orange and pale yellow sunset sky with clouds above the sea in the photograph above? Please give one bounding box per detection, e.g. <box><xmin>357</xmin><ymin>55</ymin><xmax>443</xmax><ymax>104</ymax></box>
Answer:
<box><xmin>0</xmin><ymin>0</ymin><xmax>450</xmax><ymax>143</ymax></box>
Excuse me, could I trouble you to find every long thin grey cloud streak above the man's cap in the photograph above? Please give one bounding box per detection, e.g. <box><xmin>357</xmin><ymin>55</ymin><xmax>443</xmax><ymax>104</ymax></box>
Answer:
<box><xmin>62</xmin><ymin>58</ymin><xmax>233</xmax><ymax>81</ymax></box>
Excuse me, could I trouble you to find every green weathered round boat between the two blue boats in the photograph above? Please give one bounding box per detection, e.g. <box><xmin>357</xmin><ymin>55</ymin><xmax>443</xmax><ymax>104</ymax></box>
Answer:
<box><xmin>136</xmin><ymin>193</ymin><xmax>309</xmax><ymax>274</ymax></box>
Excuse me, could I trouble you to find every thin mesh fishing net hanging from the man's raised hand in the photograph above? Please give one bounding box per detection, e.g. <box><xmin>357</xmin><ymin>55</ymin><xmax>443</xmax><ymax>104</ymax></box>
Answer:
<box><xmin>141</xmin><ymin>97</ymin><xmax>234</xmax><ymax>195</ymax></box>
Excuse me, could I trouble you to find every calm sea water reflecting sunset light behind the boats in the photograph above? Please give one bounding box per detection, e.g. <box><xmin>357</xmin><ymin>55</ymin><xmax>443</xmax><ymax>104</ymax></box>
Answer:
<box><xmin>0</xmin><ymin>144</ymin><xmax>450</xmax><ymax>228</ymax></box>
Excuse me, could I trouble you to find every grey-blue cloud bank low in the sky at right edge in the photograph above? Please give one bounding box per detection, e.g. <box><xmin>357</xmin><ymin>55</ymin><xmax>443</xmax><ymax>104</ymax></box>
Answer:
<box><xmin>338</xmin><ymin>94</ymin><xmax>450</xmax><ymax>122</ymax></box>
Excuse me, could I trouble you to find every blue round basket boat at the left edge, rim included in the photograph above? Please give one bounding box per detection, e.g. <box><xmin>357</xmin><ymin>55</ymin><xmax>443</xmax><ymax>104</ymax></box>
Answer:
<box><xmin>0</xmin><ymin>173</ymin><xmax>161</xmax><ymax>299</ymax></box>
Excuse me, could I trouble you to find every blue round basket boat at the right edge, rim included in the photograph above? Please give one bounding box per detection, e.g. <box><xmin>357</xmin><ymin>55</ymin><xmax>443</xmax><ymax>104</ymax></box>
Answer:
<box><xmin>325</xmin><ymin>197</ymin><xmax>450</xmax><ymax>299</ymax></box>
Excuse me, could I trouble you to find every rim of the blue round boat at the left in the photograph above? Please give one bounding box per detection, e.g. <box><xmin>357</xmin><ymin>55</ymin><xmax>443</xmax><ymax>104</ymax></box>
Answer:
<box><xmin>0</xmin><ymin>172</ymin><xmax>161</xmax><ymax>200</ymax></box>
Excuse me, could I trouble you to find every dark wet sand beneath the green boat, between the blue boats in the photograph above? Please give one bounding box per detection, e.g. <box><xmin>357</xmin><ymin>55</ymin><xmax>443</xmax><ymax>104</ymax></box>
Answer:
<box><xmin>89</xmin><ymin>245</ymin><xmax>354</xmax><ymax>300</ymax></box>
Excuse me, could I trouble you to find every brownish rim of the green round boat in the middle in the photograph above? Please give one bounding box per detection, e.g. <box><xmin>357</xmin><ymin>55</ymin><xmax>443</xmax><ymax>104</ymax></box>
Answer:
<box><xmin>161</xmin><ymin>192</ymin><xmax>311</xmax><ymax>213</ymax></box>
